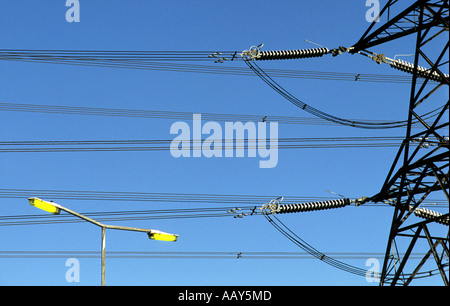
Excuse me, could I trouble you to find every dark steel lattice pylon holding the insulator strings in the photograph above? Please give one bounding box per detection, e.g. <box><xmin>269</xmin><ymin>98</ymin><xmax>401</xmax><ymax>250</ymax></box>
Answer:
<box><xmin>349</xmin><ymin>0</ymin><xmax>450</xmax><ymax>286</ymax></box>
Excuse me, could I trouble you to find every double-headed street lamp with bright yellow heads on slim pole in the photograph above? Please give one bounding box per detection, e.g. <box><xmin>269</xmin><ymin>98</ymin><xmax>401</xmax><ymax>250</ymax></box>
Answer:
<box><xmin>28</xmin><ymin>198</ymin><xmax>178</xmax><ymax>286</ymax></box>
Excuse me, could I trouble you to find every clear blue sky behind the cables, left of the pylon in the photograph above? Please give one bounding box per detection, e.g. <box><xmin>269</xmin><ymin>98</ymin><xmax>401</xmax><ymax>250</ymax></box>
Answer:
<box><xmin>0</xmin><ymin>0</ymin><xmax>441</xmax><ymax>286</ymax></box>
